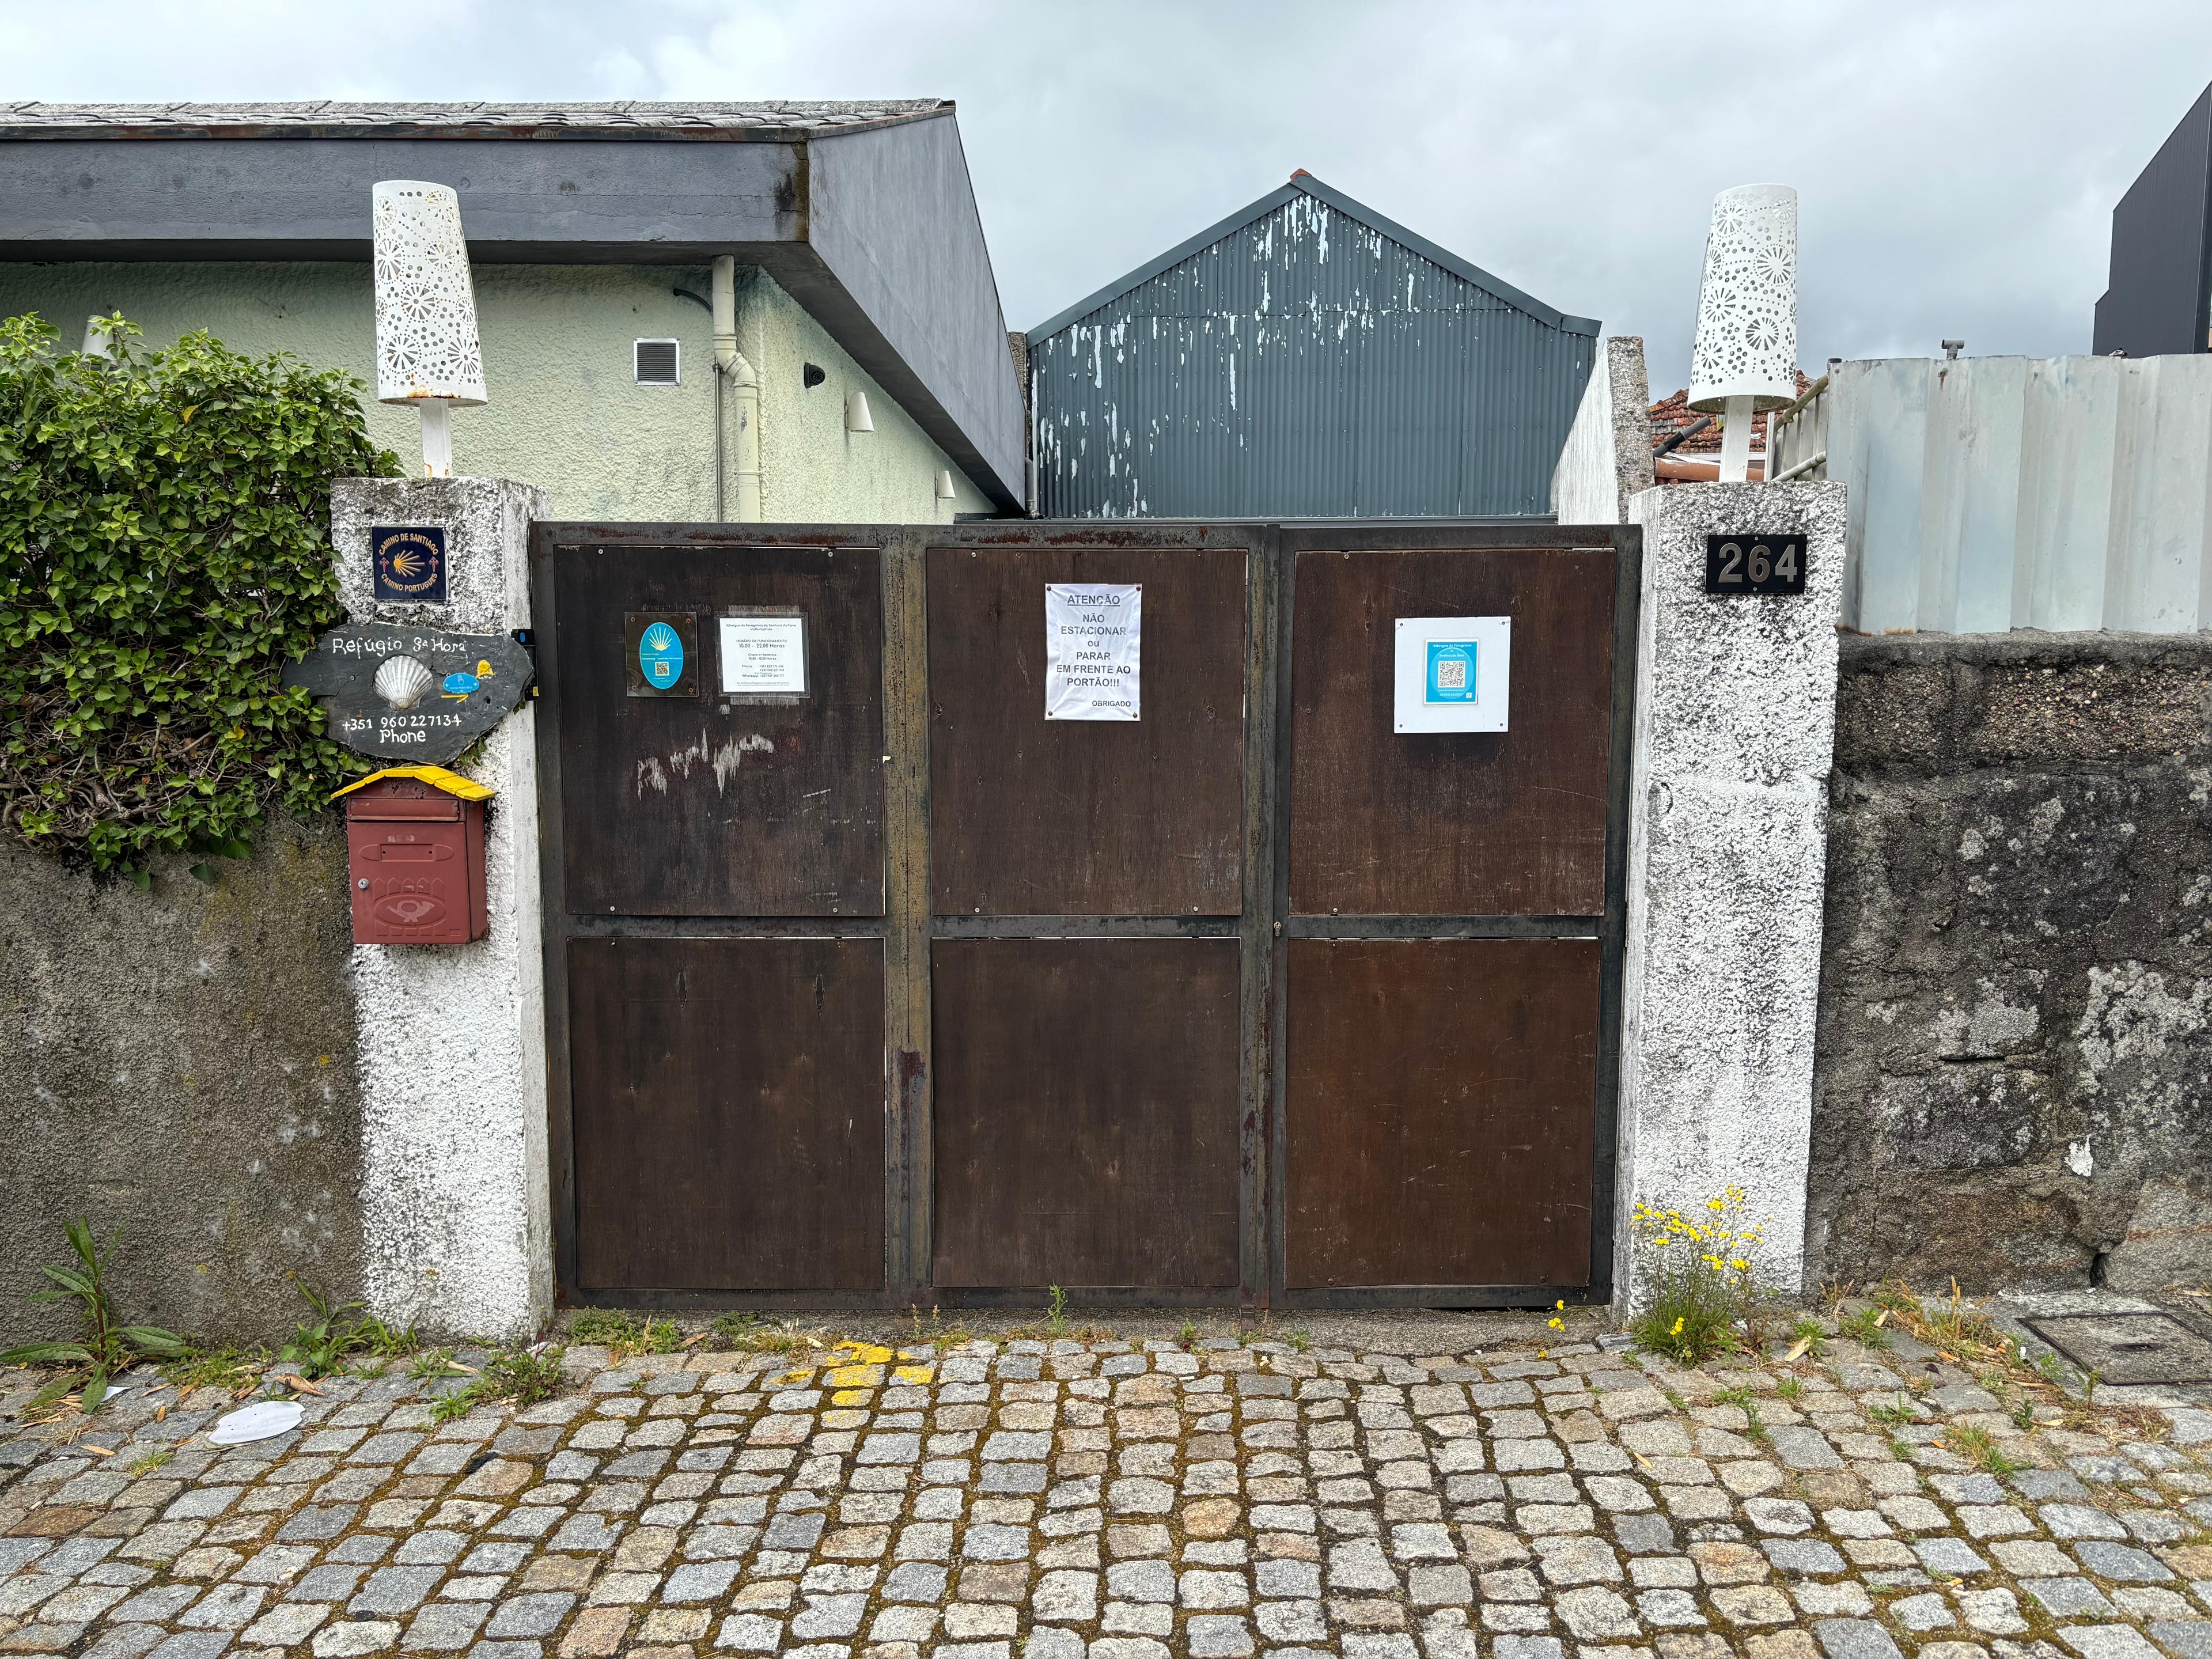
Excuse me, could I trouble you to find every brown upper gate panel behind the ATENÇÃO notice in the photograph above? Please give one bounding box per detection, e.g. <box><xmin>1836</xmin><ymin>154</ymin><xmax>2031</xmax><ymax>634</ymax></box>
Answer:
<box><xmin>929</xmin><ymin>546</ymin><xmax>1245</xmax><ymax>916</ymax></box>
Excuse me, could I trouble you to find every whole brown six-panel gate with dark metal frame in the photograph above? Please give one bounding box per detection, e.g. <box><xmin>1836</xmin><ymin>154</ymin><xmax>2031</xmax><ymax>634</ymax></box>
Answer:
<box><xmin>531</xmin><ymin>522</ymin><xmax>1639</xmax><ymax>1307</ymax></box>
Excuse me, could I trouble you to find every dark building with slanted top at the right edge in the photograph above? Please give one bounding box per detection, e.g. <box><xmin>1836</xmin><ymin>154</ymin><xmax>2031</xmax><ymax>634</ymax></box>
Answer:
<box><xmin>2090</xmin><ymin>86</ymin><xmax>2212</xmax><ymax>356</ymax></box>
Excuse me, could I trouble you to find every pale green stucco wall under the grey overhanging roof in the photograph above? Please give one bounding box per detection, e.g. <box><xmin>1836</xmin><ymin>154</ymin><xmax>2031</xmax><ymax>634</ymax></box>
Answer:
<box><xmin>0</xmin><ymin>261</ymin><xmax>995</xmax><ymax>524</ymax></box>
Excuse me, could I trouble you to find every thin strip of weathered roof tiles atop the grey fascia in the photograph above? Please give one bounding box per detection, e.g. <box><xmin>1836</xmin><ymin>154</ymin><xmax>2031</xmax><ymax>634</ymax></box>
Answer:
<box><xmin>0</xmin><ymin>97</ymin><xmax>953</xmax><ymax>142</ymax></box>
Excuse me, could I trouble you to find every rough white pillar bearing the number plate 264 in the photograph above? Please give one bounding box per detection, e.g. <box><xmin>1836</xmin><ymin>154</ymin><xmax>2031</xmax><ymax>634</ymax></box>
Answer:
<box><xmin>1615</xmin><ymin>482</ymin><xmax>1845</xmax><ymax>1307</ymax></box>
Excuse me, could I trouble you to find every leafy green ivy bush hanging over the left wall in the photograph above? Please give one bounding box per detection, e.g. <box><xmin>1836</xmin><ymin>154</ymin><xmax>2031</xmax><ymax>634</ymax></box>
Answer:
<box><xmin>0</xmin><ymin>314</ymin><xmax>398</xmax><ymax>885</ymax></box>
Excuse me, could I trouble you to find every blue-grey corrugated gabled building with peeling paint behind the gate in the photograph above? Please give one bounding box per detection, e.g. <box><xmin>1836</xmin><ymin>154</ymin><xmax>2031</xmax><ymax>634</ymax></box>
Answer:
<box><xmin>1029</xmin><ymin>173</ymin><xmax>1599</xmax><ymax>518</ymax></box>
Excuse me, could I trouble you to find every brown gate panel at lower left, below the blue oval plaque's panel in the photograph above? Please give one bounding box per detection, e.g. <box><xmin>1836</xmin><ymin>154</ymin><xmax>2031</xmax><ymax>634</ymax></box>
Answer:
<box><xmin>569</xmin><ymin>938</ymin><xmax>882</xmax><ymax>1290</ymax></box>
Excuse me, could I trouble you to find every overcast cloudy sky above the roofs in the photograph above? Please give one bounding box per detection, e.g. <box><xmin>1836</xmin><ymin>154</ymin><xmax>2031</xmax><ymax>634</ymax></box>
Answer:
<box><xmin>0</xmin><ymin>0</ymin><xmax>2212</xmax><ymax>396</ymax></box>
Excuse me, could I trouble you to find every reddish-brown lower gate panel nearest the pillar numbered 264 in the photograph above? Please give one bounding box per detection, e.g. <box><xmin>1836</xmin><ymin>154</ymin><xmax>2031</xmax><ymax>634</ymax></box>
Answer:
<box><xmin>1285</xmin><ymin>942</ymin><xmax>1601</xmax><ymax>1290</ymax></box>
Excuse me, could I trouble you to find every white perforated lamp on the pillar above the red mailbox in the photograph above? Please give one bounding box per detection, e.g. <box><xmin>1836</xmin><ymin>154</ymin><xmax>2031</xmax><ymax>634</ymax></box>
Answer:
<box><xmin>369</xmin><ymin>179</ymin><xmax>489</xmax><ymax>478</ymax></box>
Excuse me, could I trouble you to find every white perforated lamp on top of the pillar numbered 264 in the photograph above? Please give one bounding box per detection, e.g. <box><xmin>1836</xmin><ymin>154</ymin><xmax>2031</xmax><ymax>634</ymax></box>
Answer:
<box><xmin>1690</xmin><ymin>184</ymin><xmax>1796</xmax><ymax>484</ymax></box>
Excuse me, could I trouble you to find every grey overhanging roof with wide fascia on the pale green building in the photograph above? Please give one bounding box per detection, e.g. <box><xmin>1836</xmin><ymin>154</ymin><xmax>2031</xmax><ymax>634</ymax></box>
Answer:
<box><xmin>0</xmin><ymin>97</ymin><xmax>1027</xmax><ymax>509</ymax></box>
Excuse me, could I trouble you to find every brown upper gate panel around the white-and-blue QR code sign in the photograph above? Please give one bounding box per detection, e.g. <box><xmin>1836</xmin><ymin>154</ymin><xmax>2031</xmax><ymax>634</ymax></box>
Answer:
<box><xmin>1290</xmin><ymin>546</ymin><xmax>1619</xmax><ymax>916</ymax></box>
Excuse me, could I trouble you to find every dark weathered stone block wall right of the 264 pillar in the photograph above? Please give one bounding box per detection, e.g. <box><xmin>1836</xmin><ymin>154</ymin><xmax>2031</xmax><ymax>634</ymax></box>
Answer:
<box><xmin>1807</xmin><ymin>632</ymin><xmax>2212</xmax><ymax>1292</ymax></box>
